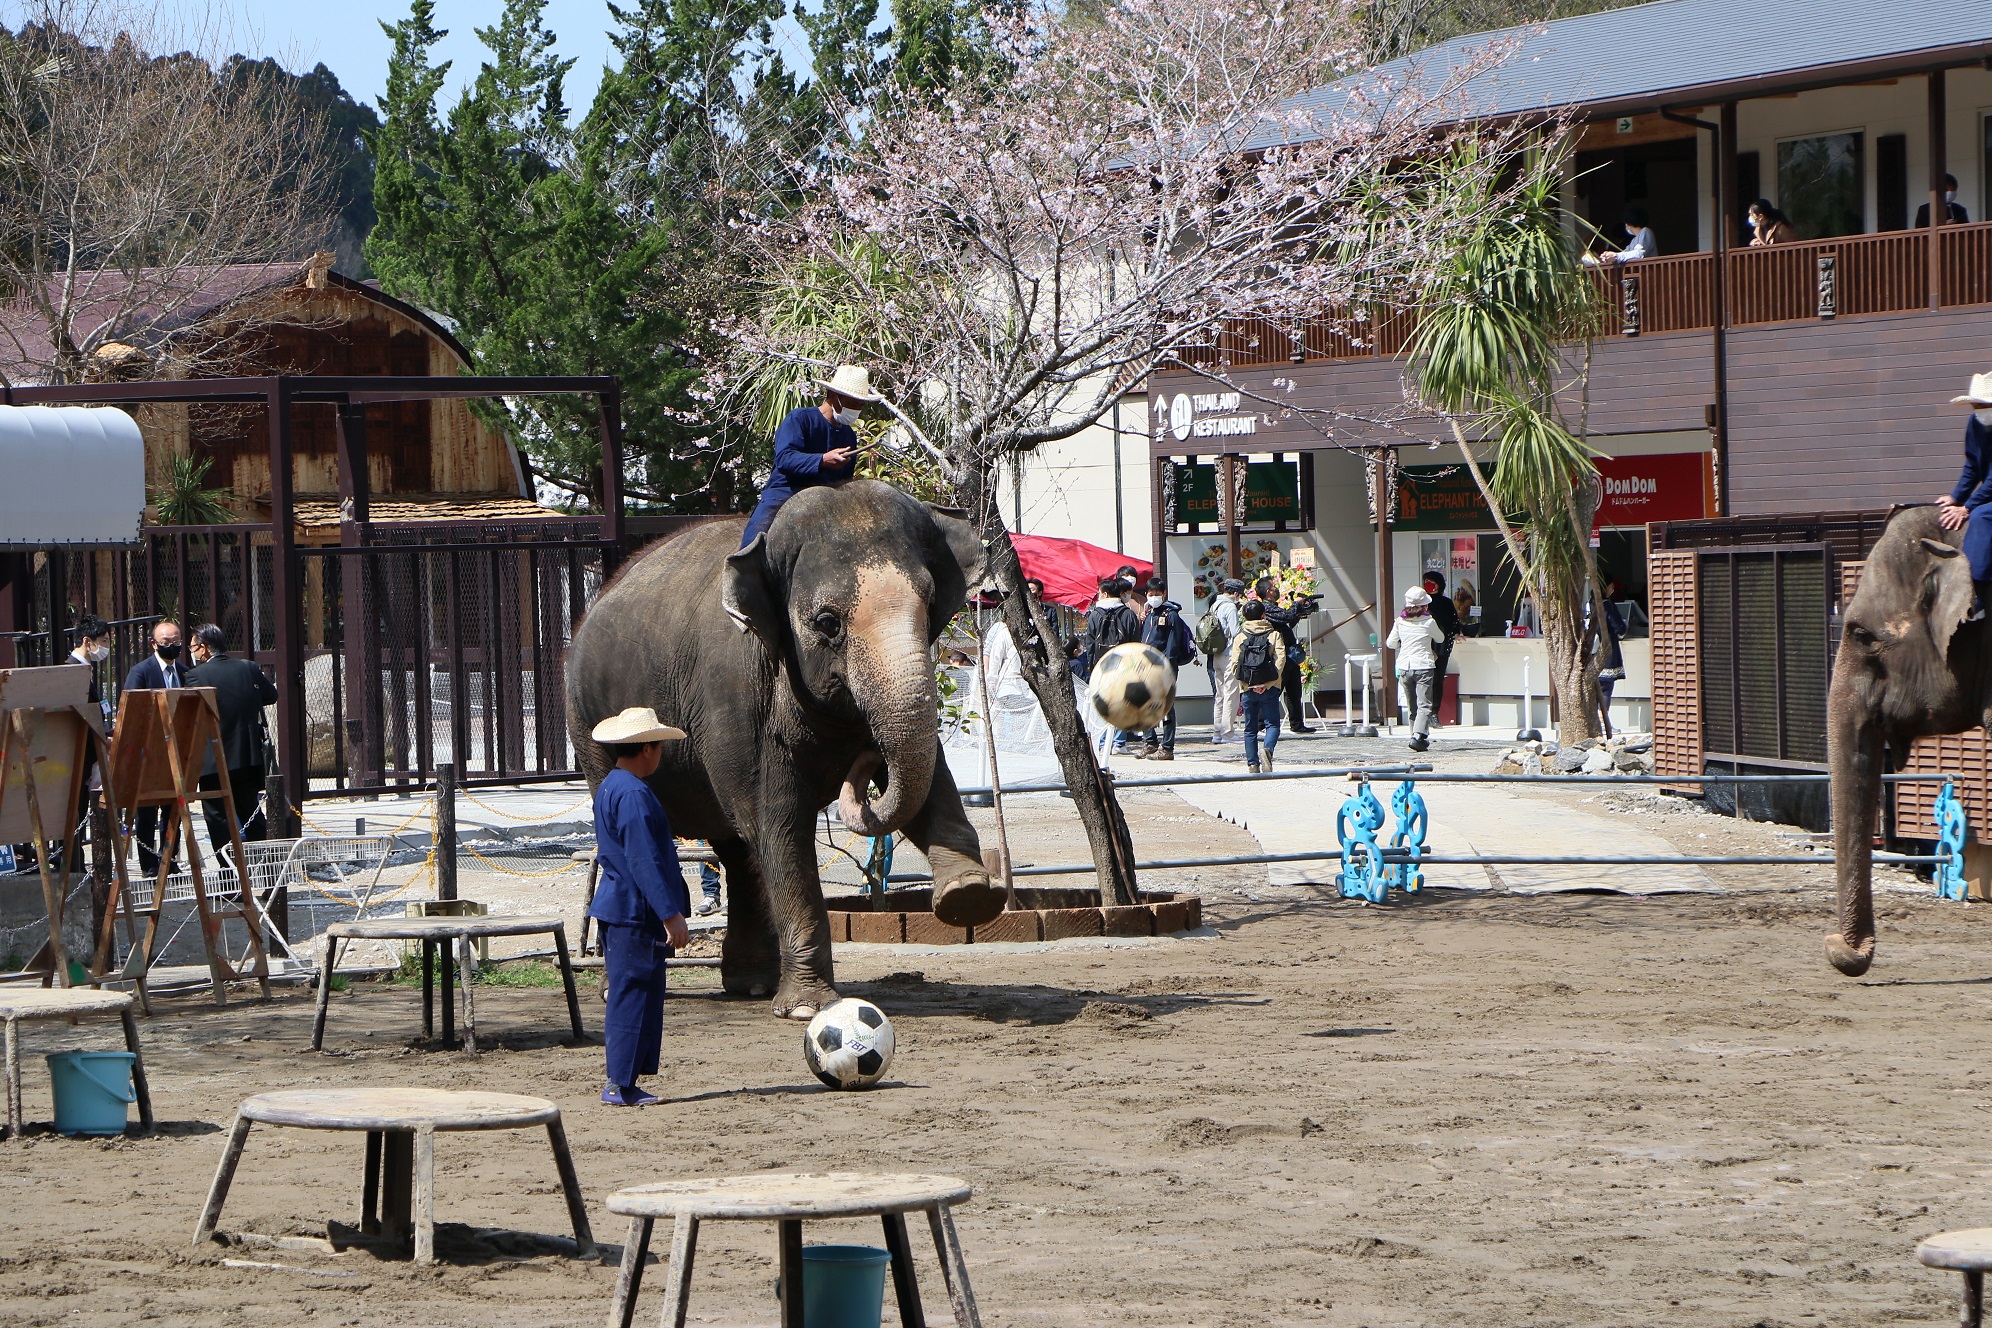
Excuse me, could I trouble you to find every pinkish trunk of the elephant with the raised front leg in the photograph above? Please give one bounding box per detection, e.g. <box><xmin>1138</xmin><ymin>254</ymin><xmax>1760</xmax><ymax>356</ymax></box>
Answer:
<box><xmin>839</xmin><ymin>575</ymin><xmax>940</xmax><ymax>836</ymax></box>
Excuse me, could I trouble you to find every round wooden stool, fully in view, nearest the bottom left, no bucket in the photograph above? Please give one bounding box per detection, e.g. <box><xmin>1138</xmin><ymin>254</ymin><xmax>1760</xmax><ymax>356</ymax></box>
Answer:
<box><xmin>193</xmin><ymin>1089</ymin><xmax>596</xmax><ymax>1264</ymax></box>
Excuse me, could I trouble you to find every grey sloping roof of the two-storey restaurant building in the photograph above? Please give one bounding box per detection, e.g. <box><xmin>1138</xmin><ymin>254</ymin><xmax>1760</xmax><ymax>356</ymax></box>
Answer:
<box><xmin>1274</xmin><ymin>0</ymin><xmax>1992</xmax><ymax>145</ymax></box>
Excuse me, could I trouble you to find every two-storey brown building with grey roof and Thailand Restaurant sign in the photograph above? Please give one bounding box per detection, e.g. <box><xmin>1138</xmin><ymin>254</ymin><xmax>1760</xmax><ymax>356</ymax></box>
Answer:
<box><xmin>1149</xmin><ymin>0</ymin><xmax>1992</xmax><ymax>780</ymax></box>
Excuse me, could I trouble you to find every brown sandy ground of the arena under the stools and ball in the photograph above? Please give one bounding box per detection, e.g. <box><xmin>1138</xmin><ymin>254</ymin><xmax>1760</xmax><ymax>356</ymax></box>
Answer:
<box><xmin>0</xmin><ymin>747</ymin><xmax>1992</xmax><ymax>1328</ymax></box>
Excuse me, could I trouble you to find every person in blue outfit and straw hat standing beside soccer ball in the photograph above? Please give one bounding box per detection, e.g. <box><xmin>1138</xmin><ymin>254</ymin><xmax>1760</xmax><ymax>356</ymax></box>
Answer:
<box><xmin>588</xmin><ymin>705</ymin><xmax>691</xmax><ymax>1107</ymax></box>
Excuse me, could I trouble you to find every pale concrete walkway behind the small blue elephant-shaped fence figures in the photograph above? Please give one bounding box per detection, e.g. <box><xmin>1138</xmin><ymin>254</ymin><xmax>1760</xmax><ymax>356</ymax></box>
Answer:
<box><xmin>1147</xmin><ymin>745</ymin><xmax>1719</xmax><ymax>894</ymax></box>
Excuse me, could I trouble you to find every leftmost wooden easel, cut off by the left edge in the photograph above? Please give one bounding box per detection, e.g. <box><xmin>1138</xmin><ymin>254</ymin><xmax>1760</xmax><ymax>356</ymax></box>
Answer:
<box><xmin>0</xmin><ymin>665</ymin><xmax>140</xmax><ymax>1013</ymax></box>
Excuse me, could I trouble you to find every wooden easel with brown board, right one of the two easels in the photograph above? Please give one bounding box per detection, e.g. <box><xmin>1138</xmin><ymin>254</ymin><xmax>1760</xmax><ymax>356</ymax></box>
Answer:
<box><xmin>104</xmin><ymin>687</ymin><xmax>269</xmax><ymax>1005</ymax></box>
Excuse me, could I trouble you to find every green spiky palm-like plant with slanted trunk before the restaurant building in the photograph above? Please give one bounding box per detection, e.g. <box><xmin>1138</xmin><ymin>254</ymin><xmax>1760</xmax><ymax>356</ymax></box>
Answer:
<box><xmin>1406</xmin><ymin>149</ymin><xmax>1602</xmax><ymax>745</ymax></box>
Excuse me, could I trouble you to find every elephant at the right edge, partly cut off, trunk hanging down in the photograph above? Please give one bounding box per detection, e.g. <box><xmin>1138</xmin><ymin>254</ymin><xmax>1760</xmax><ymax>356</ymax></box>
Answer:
<box><xmin>1827</xmin><ymin>508</ymin><xmax>1992</xmax><ymax>978</ymax></box>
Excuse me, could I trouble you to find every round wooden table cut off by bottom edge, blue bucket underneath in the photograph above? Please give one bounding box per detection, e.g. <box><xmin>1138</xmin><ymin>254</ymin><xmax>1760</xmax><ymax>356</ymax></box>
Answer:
<box><xmin>610</xmin><ymin>1171</ymin><xmax>982</xmax><ymax>1328</ymax></box>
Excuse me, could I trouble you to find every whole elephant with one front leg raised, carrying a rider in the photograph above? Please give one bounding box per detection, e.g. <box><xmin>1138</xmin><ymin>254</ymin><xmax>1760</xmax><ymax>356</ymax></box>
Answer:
<box><xmin>568</xmin><ymin>480</ymin><xmax>1004</xmax><ymax>1019</ymax></box>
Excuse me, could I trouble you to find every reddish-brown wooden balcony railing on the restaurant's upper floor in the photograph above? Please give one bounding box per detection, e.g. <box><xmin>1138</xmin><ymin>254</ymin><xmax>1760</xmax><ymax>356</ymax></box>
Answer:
<box><xmin>1181</xmin><ymin>223</ymin><xmax>1992</xmax><ymax>368</ymax></box>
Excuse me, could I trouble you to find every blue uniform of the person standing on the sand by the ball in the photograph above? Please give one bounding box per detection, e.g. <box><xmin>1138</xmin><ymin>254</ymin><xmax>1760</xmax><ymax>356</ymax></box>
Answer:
<box><xmin>588</xmin><ymin>767</ymin><xmax>691</xmax><ymax>1087</ymax></box>
